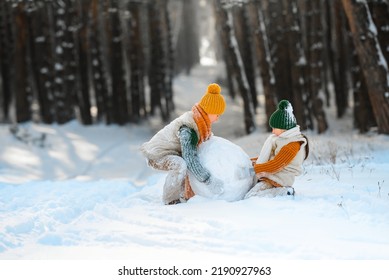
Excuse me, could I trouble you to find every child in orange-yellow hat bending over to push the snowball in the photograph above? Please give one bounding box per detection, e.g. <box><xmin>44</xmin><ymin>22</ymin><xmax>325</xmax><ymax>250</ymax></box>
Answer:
<box><xmin>141</xmin><ymin>84</ymin><xmax>226</xmax><ymax>204</ymax></box>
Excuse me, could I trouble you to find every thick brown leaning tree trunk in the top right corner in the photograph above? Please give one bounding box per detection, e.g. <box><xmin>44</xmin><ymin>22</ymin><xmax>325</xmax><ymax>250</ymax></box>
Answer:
<box><xmin>342</xmin><ymin>0</ymin><xmax>389</xmax><ymax>134</ymax></box>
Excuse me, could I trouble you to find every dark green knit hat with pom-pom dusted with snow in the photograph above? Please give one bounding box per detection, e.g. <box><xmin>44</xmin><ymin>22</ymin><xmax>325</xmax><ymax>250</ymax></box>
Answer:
<box><xmin>269</xmin><ymin>100</ymin><xmax>297</xmax><ymax>130</ymax></box>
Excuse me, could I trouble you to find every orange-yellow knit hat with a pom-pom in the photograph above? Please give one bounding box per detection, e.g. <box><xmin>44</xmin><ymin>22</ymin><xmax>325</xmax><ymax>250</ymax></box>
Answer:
<box><xmin>199</xmin><ymin>84</ymin><xmax>226</xmax><ymax>115</ymax></box>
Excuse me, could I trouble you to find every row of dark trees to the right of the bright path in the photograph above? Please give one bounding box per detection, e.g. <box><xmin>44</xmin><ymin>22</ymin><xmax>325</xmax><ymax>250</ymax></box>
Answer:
<box><xmin>214</xmin><ymin>0</ymin><xmax>389</xmax><ymax>134</ymax></box>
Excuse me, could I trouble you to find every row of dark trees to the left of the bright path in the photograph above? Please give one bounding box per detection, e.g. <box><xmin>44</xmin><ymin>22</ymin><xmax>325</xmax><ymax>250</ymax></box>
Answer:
<box><xmin>0</xmin><ymin>0</ymin><xmax>198</xmax><ymax>124</ymax></box>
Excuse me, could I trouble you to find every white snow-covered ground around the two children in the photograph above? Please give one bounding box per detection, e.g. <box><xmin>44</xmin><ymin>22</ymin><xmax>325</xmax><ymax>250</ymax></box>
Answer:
<box><xmin>0</xmin><ymin>67</ymin><xmax>389</xmax><ymax>260</ymax></box>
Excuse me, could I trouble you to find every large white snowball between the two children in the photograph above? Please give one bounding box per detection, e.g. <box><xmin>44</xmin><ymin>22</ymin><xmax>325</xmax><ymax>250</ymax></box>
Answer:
<box><xmin>189</xmin><ymin>136</ymin><xmax>254</xmax><ymax>201</ymax></box>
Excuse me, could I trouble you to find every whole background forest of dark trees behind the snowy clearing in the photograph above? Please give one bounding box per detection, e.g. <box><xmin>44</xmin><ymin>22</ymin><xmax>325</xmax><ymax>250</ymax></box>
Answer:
<box><xmin>0</xmin><ymin>0</ymin><xmax>389</xmax><ymax>134</ymax></box>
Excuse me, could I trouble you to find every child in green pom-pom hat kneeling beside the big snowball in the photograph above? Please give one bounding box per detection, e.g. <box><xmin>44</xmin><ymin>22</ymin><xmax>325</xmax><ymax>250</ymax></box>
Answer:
<box><xmin>245</xmin><ymin>100</ymin><xmax>309</xmax><ymax>198</ymax></box>
